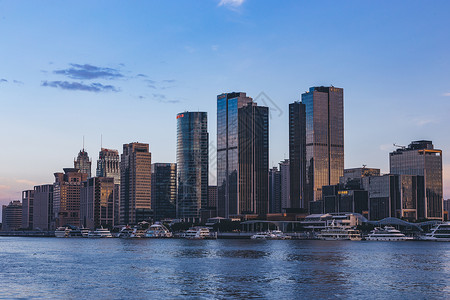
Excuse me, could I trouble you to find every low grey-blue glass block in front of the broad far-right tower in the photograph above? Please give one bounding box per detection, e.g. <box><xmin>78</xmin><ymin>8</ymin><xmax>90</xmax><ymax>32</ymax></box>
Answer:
<box><xmin>362</xmin><ymin>174</ymin><xmax>424</xmax><ymax>221</ymax></box>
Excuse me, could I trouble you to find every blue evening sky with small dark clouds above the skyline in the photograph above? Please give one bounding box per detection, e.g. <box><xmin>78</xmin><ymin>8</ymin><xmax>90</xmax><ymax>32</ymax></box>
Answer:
<box><xmin>0</xmin><ymin>0</ymin><xmax>450</xmax><ymax>211</ymax></box>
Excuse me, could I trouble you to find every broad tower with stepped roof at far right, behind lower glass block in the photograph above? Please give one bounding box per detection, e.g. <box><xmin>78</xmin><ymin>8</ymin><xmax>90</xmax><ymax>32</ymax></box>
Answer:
<box><xmin>389</xmin><ymin>141</ymin><xmax>443</xmax><ymax>220</ymax></box>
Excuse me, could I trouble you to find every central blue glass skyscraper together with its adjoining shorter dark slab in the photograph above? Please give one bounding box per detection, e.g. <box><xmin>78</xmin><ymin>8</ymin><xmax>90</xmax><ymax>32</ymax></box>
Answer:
<box><xmin>217</xmin><ymin>93</ymin><xmax>269</xmax><ymax>217</ymax></box>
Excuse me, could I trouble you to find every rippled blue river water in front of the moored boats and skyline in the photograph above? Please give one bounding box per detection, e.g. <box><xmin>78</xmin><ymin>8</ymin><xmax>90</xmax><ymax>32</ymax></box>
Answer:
<box><xmin>0</xmin><ymin>237</ymin><xmax>450</xmax><ymax>299</ymax></box>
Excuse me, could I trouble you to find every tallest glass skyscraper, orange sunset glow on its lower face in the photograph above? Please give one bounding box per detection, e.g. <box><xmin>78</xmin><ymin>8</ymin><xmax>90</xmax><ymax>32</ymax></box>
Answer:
<box><xmin>302</xmin><ymin>86</ymin><xmax>344</xmax><ymax>210</ymax></box>
